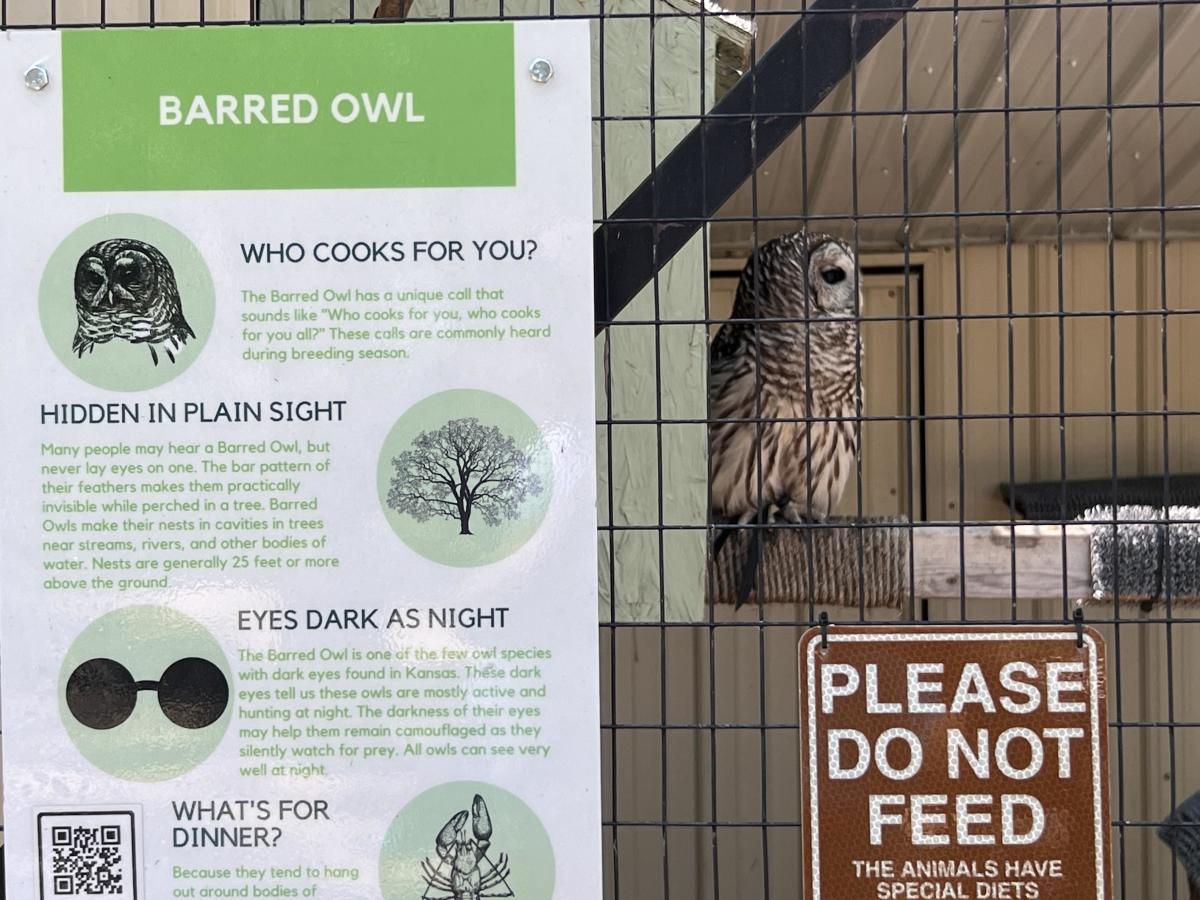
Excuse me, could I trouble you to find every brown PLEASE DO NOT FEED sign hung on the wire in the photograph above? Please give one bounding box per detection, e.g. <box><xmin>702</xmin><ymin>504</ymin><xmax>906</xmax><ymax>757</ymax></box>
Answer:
<box><xmin>799</xmin><ymin>625</ymin><xmax>1111</xmax><ymax>900</ymax></box>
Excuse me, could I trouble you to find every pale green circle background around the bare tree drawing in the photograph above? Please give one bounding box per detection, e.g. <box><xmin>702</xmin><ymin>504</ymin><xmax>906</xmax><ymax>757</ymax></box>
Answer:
<box><xmin>377</xmin><ymin>390</ymin><xmax>553</xmax><ymax>566</ymax></box>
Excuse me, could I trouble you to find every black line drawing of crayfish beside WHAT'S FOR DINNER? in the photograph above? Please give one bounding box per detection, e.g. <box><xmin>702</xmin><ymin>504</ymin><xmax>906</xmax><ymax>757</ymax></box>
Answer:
<box><xmin>421</xmin><ymin>793</ymin><xmax>516</xmax><ymax>900</ymax></box>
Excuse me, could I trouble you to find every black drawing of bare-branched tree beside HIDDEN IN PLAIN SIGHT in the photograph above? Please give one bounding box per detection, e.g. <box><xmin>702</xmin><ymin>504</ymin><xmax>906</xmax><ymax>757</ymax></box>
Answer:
<box><xmin>388</xmin><ymin>418</ymin><xmax>542</xmax><ymax>534</ymax></box>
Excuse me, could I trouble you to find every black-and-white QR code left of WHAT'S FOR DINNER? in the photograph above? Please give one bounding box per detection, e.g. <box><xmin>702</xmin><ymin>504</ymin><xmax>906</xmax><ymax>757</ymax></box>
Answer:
<box><xmin>37</xmin><ymin>810</ymin><xmax>139</xmax><ymax>900</ymax></box>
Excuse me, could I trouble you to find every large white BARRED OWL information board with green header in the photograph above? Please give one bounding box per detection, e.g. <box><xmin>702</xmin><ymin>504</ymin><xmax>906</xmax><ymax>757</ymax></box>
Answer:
<box><xmin>0</xmin><ymin>22</ymin><xmax>601</xmax><ymax>900</ymax></box>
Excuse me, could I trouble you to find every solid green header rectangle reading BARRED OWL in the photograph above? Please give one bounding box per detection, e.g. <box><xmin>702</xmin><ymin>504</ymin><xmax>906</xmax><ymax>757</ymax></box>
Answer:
<box><xmin>62</xmin><ymin>23</ymin><xmax>516</xmax><ymax>191</ymax></box>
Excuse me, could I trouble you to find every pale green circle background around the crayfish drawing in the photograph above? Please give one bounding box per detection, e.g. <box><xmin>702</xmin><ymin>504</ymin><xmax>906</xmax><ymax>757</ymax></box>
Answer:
<box><xmin>379</xmin><ymin>781</ymin><xmax>554</xmax><ymax>900</ymax></box>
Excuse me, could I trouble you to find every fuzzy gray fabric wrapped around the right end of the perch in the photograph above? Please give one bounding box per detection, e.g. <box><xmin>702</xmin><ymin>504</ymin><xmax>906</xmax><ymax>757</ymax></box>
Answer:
<box><xmin>1081</xmin><ymin>506</ymin><xmax>1200</xmax><ymax>602</ymax></box>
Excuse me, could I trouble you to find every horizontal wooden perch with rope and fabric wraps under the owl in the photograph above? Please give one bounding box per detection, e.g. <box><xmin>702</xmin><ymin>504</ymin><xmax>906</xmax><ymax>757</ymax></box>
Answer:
<box><xmin>708</xmin><ymin>518</ymin><xmax>1200</xmax><ymax>610</ymax></box>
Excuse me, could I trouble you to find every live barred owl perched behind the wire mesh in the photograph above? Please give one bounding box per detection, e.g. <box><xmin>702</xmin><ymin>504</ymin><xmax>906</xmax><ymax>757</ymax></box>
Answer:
<box><xmin>708</xmin><ymin>233</ymin><xmax>862</xmax><ymax>605</ymax></box>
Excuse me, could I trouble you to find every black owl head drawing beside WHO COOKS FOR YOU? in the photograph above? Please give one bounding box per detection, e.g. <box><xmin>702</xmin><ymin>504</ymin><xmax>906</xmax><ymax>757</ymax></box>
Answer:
<box><xmin>71</xmin><ymin>238</ymin><xmax>196</xmax><ymax>366</ymax></box>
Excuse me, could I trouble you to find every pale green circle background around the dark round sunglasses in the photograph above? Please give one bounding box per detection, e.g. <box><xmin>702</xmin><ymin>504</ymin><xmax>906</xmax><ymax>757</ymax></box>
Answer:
<box><xmin>59</xmin><ymin>606</ymin><xmax>234</xmax><ymax>781</ymax></box>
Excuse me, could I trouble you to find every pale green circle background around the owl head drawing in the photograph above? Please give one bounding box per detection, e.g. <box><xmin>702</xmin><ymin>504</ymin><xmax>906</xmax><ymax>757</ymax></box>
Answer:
<box><xmin>37</xmin><ymin>212</ymin><xmax>216</xmax><ymax>391</ymax></box>
